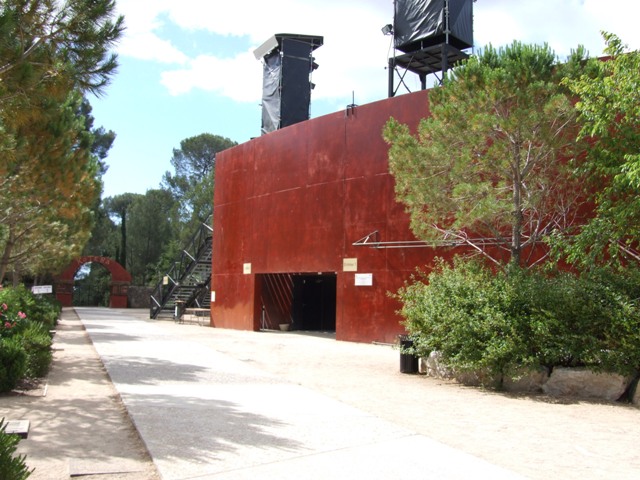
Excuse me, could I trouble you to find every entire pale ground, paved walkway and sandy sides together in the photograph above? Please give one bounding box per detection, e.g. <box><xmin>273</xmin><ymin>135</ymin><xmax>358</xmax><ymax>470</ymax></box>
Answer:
<box><xmin>5</xmin><ymin>308</ymin><xmax>640</xmax><ymax>480</ymax></box>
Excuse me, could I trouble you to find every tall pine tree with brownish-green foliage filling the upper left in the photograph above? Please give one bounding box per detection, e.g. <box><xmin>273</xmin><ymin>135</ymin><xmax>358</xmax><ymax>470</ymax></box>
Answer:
<box><xmin>0</xmin><ymin>0</ymin><xmax>123</xmax><ymax>282</ymax></box>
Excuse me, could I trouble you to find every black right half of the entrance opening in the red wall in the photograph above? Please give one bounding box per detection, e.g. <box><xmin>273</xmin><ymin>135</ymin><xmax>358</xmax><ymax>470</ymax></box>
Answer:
<box><xmin>292</xmin><ymin>273</ymin><xmax>336</xmax><ymax>332</ymax></box>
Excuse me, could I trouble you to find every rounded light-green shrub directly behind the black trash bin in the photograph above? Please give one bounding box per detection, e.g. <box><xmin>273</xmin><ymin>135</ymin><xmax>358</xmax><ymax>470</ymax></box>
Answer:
<box><xmin>398</xmin><ymin>261</ymin><xmax>535</xmax><ymax>382</ymax></box>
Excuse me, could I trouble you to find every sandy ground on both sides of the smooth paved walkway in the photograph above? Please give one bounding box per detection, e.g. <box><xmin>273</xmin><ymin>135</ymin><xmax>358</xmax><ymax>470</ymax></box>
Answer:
<box><xmin>0</xmin><ymin>310</ymin><xmax>640</xmax><ymax>480</ymax></box>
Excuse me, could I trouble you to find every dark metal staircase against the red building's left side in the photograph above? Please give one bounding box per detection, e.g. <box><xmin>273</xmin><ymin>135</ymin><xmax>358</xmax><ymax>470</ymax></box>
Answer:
<box><xmin>149</xmin><ymin>217</ymin><xmax>213</xmax><ymax>318</ymax></box>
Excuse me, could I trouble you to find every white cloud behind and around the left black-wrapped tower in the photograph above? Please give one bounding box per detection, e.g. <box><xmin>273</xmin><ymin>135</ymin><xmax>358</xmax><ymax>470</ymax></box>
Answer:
<box><xmin>120</xmin><ymin>0</ymin><xmax>393</xmax><ymax>102</ymax></box>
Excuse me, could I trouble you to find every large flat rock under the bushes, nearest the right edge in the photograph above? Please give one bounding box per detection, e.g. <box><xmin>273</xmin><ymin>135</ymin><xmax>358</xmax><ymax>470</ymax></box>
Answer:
<box><xmin>542</xmin><ymin>367</ymin><xmax>629</xmax><ymax>402</ymax></box>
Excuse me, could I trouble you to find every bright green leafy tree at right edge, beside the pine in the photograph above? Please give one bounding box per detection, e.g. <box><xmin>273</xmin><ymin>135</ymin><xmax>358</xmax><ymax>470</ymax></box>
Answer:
<box><xmin>566</xmin><ymin>33</ymin><xmax>640</xmax><ymax>266</ymax></box>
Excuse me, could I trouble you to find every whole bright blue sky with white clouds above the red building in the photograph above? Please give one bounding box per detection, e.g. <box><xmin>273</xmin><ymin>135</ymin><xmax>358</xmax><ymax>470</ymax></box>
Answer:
<box><xmin>90</xmin><ymin>0</ymin><xmax>640</xmax><ymax>197</ymax></box>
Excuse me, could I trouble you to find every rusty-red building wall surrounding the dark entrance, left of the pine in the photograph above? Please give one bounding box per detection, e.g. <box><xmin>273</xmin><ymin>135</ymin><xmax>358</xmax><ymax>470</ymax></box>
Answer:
<box><xmin>211</xmin><ymin>92</ymin><xmax>443</xmax><ymax>342</ymax></box>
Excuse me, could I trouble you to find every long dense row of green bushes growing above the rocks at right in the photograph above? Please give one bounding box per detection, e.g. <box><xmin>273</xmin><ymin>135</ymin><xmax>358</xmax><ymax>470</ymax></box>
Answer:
<box><xmin>397</xmin><ymin>259</ymin><xmax>640</xmax><ymax>379</ymax></box>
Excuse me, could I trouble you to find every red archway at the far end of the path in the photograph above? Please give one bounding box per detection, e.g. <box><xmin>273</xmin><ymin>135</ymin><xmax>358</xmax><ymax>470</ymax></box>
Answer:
<box><xmin>55</xmin><ymin>256</ymin><xmax>131</xmax><ymax>308</ymax></box>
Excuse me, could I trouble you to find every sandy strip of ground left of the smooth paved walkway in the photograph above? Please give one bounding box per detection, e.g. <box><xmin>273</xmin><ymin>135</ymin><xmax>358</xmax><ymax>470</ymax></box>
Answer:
<box><xmin>0</xmin><ymin>309</ymin><xmax>160</xmax><ymax>480</ymax></box>
